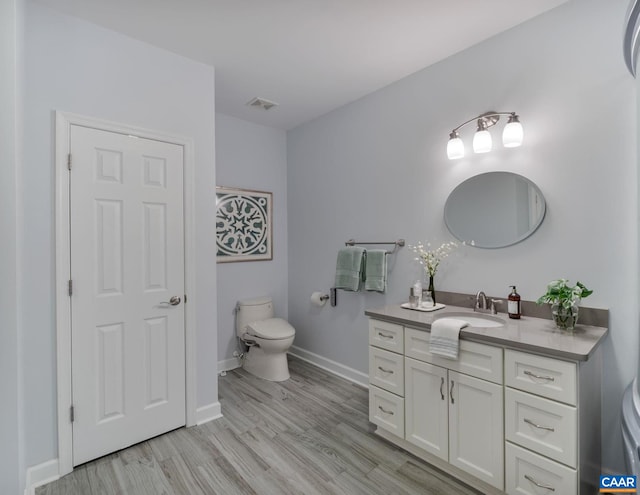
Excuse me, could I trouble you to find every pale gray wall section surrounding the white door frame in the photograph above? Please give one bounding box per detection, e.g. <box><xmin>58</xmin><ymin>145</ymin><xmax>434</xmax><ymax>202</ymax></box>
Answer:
<box><xmin>20</xmin><ymin>2</ymin><xmax>218</xmax><ymax>466</ymax></box>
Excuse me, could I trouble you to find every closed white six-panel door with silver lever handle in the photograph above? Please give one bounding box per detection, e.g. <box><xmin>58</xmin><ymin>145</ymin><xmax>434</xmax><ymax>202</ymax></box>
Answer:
<box><xmin>70</xmin><ymin>125</ymin><xmax>185</xmax><ymax>465</ymax></box>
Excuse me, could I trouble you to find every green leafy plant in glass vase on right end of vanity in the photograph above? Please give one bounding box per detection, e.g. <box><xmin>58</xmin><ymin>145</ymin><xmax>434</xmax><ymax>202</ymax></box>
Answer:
<box><xmin>537</xmin><ymin>278</ymin><xmax>593</xmax><ymax>331</ymax></box>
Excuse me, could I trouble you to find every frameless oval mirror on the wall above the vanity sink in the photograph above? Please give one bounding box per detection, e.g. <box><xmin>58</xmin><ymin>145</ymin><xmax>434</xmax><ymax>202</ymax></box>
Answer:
<box><xmin>444</xmin><ymin>172</ymin><xmax>546</xmax><ymax>248</ymax></box>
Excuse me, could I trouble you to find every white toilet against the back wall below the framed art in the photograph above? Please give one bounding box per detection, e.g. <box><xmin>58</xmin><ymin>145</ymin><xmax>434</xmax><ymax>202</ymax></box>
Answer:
<box><xmin>236</xmin><ymin>297</ymin><xmax>296</xmax><ymax>382</ymax></box>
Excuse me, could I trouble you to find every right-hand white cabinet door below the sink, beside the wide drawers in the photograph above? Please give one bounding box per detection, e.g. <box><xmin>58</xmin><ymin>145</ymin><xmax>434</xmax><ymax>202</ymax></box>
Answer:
<box><xmin>448</xmin><ymin>371</ymin><xmax>504</xmax><ymax>490</ymax></box>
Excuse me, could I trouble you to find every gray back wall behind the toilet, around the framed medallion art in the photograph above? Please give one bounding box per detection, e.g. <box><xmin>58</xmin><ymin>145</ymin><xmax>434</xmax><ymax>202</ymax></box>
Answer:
<box><xmin>216</xmin><ymin>113</ymin><xmax>288</xmax><ymax>367</ymax></box>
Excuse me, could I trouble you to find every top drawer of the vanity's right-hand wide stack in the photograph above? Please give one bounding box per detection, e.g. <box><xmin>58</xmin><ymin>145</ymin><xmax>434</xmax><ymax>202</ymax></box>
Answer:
<box><xmin>504</xmin><ymin>350</ymin><xmax>578</xmax><ymax>406</ymax></box>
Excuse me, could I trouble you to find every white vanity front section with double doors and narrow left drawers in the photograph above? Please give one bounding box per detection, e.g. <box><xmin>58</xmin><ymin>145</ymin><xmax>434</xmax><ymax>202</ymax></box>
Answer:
<box><xmin>369</xmin><ymin>319</ymin><xmax>504</xmax><ymax>490</ymax></box>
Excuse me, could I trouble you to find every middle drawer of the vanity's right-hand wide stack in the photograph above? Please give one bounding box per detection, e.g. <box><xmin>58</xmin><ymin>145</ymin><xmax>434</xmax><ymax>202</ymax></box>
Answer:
<box><xmin>504</xmin><ymin>388</ymin><xmax>578</xmax><ymax>468</ymax></box>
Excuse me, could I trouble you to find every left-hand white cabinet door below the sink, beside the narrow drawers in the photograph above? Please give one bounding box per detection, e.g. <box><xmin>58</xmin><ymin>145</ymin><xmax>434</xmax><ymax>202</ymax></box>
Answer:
<box><xmin>405</xmin><ymin>358</ymin><xmax>449</xmax><ymax>461</ymax></box>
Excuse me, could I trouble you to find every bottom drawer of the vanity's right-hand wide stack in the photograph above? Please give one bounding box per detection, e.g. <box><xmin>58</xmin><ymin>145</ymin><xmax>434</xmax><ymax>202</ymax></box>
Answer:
<box><xmin>505</xmin><ymin>442</ymin><xmax>578</xmax><ymax>495</ymax></box>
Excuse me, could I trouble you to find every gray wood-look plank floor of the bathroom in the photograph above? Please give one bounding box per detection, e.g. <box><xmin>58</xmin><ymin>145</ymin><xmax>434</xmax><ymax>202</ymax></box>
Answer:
<box><xmin>36</xmin><ymin>358</ymin><xmax>479</xmax><ymax>495</ymax></box>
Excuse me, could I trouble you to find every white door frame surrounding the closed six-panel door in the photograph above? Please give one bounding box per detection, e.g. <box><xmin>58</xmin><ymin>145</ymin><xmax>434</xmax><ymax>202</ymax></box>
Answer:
<box><xmin>55</xmin><ymin>111</ymin><xmax>197</xmax><ymax>476</ymax></box>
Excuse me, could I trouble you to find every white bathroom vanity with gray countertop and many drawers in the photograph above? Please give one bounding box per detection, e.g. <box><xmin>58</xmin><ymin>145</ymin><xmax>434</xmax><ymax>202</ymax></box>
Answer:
<box><xmin>365</xmin><ymin>305</ymin><xmax>608</xmax><ymax>495</ymax></box>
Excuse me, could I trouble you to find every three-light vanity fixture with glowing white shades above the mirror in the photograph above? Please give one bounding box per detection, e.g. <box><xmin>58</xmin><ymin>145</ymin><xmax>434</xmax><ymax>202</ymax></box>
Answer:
<box><xmin>447</xmin><ymin>112</ymin><xmax>524</xmax><ymax>160</ymax></box>
